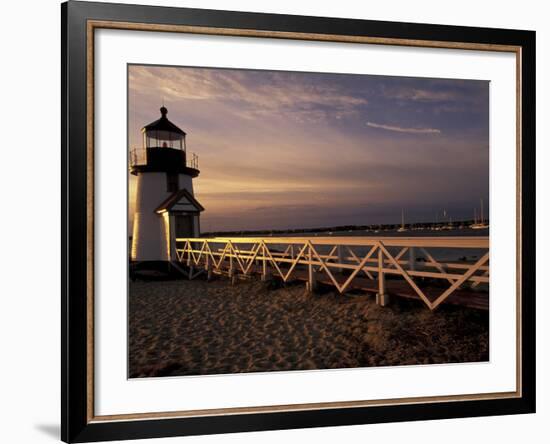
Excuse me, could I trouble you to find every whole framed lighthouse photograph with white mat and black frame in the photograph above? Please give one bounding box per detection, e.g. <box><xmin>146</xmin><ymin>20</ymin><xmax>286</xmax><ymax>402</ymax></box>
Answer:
<box><xmin>61</xmin><ymin>1</ymin><xmax>535</xmax><ymax>442</ymax></box>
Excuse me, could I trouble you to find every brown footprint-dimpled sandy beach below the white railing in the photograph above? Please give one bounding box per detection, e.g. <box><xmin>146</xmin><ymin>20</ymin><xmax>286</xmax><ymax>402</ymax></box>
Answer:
<box><xmin>129</xmin><ymin>278</ymin><xmax>489</xmax><ymax>378</ymax></box>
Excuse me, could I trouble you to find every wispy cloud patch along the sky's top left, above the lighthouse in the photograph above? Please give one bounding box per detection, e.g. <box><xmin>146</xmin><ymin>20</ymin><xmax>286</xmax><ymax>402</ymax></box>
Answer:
<box><xmin>129</xmin><ymin>66</ymin><xmax>367</xmax><ymax>122</ymax></box>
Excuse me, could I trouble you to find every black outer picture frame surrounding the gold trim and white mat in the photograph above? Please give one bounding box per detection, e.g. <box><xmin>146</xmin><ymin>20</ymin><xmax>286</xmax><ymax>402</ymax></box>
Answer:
<box><xmin>61</xmin><ymin>1</ymin><xmax>535</xmax><ymax>442</ymax></box>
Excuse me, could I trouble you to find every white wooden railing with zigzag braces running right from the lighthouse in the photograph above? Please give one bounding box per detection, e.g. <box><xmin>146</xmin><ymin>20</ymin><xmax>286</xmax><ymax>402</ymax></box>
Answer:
<box><xmin>175</xmin><ymin>237</ymin><xmax>489</xmax><ymax>310</ymax></box>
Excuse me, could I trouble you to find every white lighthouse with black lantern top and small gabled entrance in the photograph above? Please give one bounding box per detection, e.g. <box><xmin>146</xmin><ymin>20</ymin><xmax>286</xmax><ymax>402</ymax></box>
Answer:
<box><xmin>130</xmin><ymin>106</ymin><xmax>204</xmax><ymax>269</ymax></box>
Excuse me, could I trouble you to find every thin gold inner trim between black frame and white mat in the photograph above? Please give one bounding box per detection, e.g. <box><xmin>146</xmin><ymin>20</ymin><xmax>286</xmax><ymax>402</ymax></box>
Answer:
<box><xmin>86</xmin><ymin>20</ymin><xmax>522</xmax><ymax>423</ymax></box>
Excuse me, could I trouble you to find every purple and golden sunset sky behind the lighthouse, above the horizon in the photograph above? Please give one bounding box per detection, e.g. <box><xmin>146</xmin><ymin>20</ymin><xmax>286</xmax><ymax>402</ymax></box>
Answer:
<box><xmin>129</xmin><ymin>66</ymin><xmax>489</xmax><ymax>231</ymax></box>
